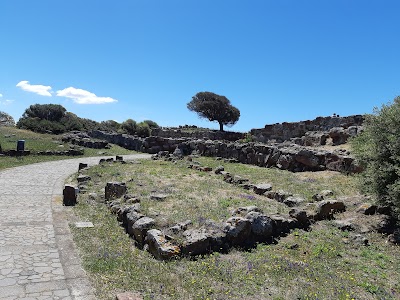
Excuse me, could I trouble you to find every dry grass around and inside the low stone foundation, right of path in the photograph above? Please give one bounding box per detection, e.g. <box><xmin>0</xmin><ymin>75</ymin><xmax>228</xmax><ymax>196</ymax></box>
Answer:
<box><xmin>71</xmin><ymin>158</ymin><xmax>400</xmax><ymax>300</ymax></box>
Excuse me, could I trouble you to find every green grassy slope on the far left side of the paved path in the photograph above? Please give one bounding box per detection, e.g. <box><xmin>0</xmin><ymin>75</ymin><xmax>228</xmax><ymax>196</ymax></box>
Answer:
<box><xmin>0</xmin><ymin>126</ymin><xmax>133</xmax><ymax>170</ymax></box>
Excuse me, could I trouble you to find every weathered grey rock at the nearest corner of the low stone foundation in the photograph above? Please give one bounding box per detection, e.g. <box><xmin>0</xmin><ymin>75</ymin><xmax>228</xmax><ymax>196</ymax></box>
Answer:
<box><xmin>146</xmin><ymin>229</ymin><xmax>181</xmax><ymax>260</ymax></box>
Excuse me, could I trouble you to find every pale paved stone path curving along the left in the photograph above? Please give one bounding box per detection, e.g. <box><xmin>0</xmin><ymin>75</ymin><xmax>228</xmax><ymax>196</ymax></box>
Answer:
<box><xmin>0</xmin><ymin>154</ymin><xmax>149</xmax><ymax>300</ymax></box>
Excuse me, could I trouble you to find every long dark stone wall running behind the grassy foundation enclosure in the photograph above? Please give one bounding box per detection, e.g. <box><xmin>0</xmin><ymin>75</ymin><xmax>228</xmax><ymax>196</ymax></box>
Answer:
<box><xmin>90</xmin><ymin>131</ymin><xmax>361</xmax><ymax>173</ymax></box>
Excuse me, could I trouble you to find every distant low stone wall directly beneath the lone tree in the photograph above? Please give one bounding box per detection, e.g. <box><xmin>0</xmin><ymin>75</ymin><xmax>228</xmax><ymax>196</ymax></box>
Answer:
<box><xmin>151</xmin><ymin>128</ymin><xmax>245</xmax><ymax>141</ymax></box>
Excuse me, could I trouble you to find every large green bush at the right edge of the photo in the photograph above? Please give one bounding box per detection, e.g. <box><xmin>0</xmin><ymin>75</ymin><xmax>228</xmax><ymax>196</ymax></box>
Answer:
<box><xmin>351</xmin><ymin>97</ymin><xmax>400</xmax><ymax>217</ymax></box>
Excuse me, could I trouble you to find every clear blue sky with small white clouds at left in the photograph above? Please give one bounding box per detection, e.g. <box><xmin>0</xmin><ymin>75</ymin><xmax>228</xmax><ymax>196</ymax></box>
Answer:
<box><xmin>0</xmin><ymin>0</ymin><xmax>400</xmax><ymax>131</ymax></box>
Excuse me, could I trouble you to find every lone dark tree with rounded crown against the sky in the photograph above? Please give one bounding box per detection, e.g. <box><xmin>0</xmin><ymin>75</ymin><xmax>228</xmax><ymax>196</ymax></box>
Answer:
<box><xmin>187</xmin><ymin>92</ymin><xmax>240</xmax><ymax>131</ymax></box>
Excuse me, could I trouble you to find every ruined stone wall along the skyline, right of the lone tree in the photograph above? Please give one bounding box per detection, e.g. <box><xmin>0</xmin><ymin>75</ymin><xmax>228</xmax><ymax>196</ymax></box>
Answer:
<box><xmin>250</xmin><ymin>115</ymin><xmax>364</xmax><ymax>143</ymax></box>
